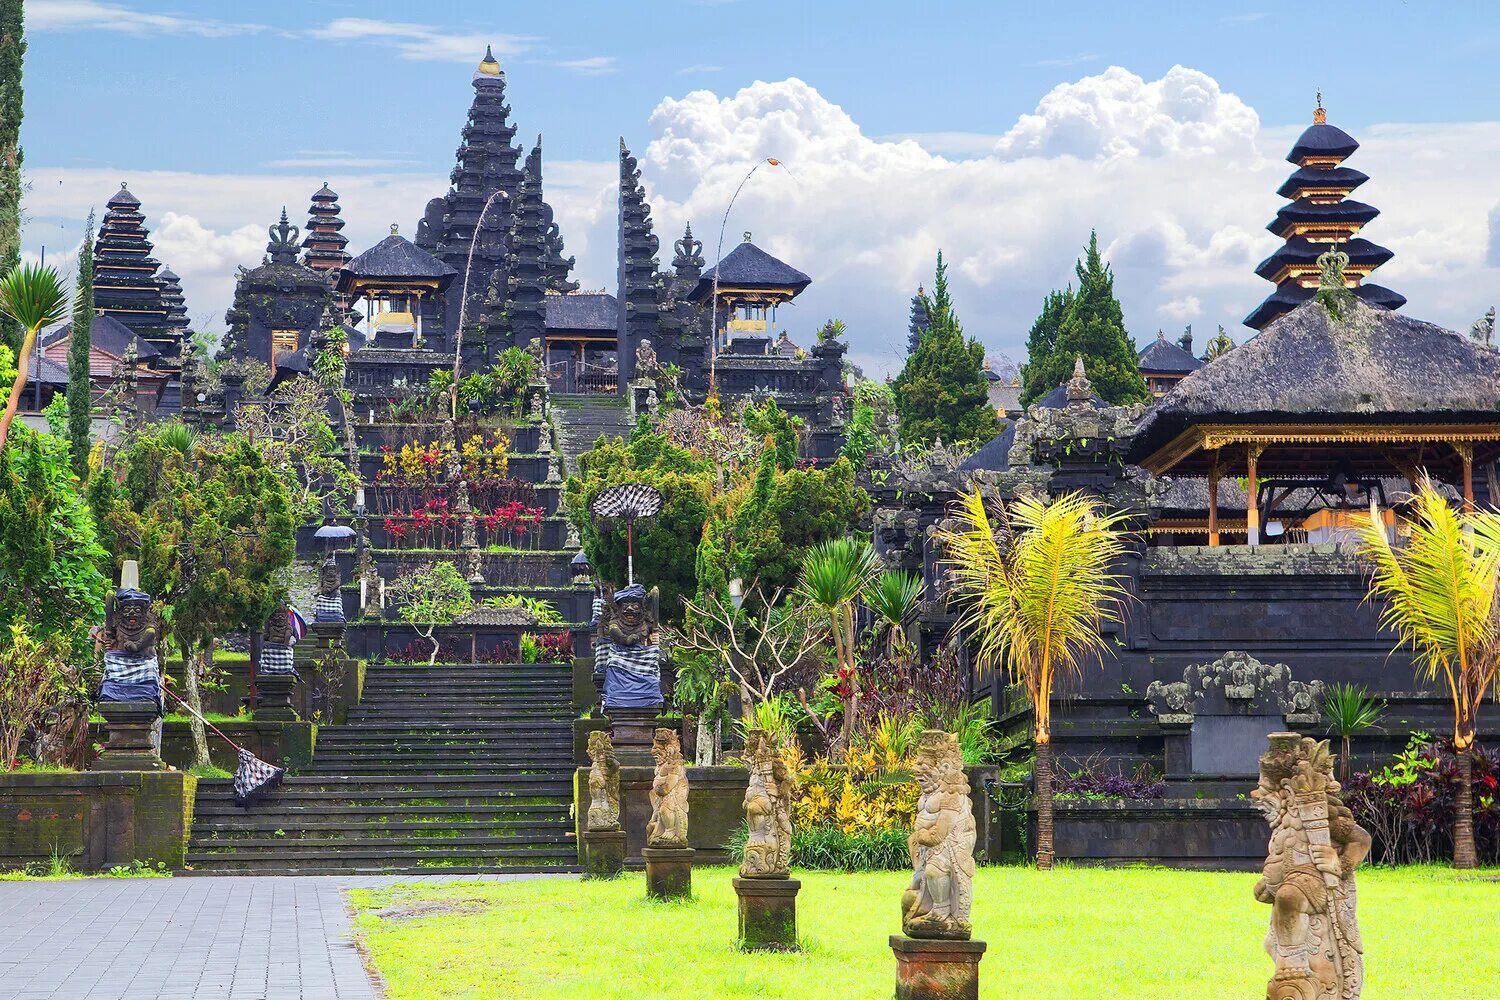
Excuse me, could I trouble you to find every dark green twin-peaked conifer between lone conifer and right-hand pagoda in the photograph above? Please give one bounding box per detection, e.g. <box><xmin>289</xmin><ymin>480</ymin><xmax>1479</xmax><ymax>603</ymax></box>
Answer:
<box><xmin>1028</xmin><ymin>232</ymin><xmax>1151</xmax><ymax>406</ymax></box>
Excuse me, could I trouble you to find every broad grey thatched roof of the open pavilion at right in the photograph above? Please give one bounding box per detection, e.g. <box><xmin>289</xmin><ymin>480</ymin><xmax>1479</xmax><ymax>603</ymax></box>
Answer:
<box><xmin>1131</xmin><ymin>297</ymin><xmax>1500</xmax><ymax>473</ymax></box>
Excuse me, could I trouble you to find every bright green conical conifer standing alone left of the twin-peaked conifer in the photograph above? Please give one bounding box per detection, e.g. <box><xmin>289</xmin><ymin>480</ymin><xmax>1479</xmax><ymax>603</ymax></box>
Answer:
<box><xmin>894</xmin><ymin>252</ymin><xmax>1001</xmax><ymax>444</ymax></box>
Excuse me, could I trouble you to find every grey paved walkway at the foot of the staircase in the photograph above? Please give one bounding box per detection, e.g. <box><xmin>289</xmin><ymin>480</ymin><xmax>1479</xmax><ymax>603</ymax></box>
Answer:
<box><xmin>0</xmin><ymin>876</ymin><xmax>558</xmax><ymax>1000</ymax></box>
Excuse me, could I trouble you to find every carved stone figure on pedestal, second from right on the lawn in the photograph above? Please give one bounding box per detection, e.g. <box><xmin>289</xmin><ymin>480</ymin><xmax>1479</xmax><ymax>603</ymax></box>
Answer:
<box><xmin>902</xmin><ymin>729</ymin><xmax>977</xmax><ymax>942</ymax></box>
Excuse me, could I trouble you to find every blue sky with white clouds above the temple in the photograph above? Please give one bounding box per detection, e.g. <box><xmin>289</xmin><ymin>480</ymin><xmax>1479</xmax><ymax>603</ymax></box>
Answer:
<box><xmin>23</xmin><ymin>0</ymin><xmax>1500</xmax><ymax>367</ymax></box>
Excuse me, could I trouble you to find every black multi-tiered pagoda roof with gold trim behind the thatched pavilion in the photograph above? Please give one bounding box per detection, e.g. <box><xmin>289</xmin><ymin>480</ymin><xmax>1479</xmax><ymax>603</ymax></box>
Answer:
<box><xmin>1245</xmin><ymin>97</ymin><xmax>1406</xmax><ymax>330</ymax></box>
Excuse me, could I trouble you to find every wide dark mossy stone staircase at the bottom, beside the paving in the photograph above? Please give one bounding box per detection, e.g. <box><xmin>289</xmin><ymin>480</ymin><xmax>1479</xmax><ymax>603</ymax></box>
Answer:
<box><xmin>185</xmin><ymin>664</ymin><xmax>578</xmax><ymax>874</ymax></box>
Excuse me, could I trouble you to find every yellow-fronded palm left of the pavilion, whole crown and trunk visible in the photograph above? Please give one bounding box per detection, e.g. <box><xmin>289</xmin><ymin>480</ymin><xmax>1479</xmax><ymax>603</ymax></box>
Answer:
<box><xmin>938</xmin><ymin>487</ymin><xmax>1127</xmax><ymax>868</ymax></box>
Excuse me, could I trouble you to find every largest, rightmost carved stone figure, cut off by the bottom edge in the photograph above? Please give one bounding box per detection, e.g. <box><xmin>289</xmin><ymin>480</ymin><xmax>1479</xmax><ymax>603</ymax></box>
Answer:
<box><xmin>1250</xmin><ymin>733</ymin><xmax>1370</xmax><ymax>1000</ymax></box>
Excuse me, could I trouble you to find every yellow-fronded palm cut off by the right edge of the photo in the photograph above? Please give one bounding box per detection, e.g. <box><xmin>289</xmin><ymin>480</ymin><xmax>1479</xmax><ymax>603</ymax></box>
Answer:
<box><xmin>1361</xmin><ymin>475</ymin><xmax>1500</xmax><ymax>868</ymax></box>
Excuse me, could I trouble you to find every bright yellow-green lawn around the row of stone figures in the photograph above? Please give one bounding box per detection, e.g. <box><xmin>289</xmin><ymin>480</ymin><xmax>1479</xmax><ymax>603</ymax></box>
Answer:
<box><xmin>350</xmin><ymin>868</ymin><xmax>1500</xmax><ymax>1000</ymax></box>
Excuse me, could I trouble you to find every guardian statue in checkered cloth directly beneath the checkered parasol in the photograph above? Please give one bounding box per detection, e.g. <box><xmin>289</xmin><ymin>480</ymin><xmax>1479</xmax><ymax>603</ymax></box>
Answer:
<box><xmin>593</xmin><ymin>583</ymin><xmax>662</xmax><ymax>711</ymax></box>
